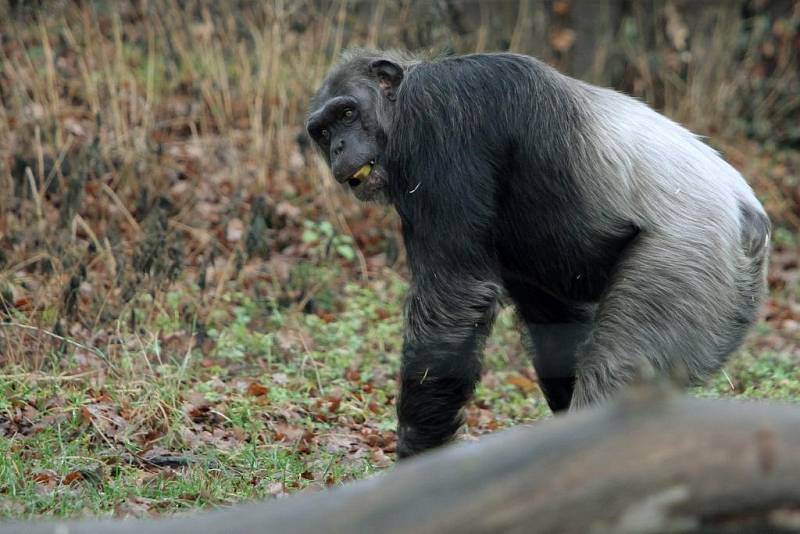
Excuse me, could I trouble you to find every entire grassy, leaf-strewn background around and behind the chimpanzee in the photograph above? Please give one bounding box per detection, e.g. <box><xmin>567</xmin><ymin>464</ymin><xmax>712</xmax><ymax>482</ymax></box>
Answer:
<box><xmin>0</xmin><ymin>0</ymin><xmax>800</xmax><ymax>517</ymax></box>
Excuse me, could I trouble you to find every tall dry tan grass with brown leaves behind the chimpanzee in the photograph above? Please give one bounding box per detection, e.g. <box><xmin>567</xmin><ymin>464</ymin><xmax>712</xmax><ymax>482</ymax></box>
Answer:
<box><xmin>0</xmin><ymin>0</ymin><xmax>800</xmax><ymax>368</ymax></box>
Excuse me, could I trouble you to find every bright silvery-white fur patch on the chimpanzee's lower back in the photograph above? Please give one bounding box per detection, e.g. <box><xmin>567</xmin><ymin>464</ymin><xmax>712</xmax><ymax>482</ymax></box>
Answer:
<box><xmin>581</xmin><ymin>84</ymin><xmax>762</xmax><ymax>243</ymax></box>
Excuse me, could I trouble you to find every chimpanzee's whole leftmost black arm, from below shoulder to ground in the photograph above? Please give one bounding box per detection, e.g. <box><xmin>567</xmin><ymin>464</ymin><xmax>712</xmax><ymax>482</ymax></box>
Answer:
<box><xmin>397</xmin><ymin>209</ymin><xmax>501</xmax><ymax>458</ymax></box>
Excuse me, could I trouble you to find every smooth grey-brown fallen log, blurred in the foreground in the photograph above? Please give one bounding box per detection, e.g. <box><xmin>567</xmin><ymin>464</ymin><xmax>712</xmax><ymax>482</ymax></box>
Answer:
<box><xmin>9</xmin><ymin>389</ymin><xmax>800</xmax><ymax>534</ymax></box>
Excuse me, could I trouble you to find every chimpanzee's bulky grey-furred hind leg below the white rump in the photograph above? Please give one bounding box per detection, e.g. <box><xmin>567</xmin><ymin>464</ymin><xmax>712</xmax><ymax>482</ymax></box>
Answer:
<box><xmin>570</xmin><ymin>233</ymin><xmax>763</xmax><ymax>409</ymax></box>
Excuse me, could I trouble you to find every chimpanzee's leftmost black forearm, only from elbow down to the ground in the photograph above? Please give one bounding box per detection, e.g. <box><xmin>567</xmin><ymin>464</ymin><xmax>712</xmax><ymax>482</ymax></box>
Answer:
<box><xmin>397</xmin><ymin>276</ymin><xmax>500</xmax><ymax>458</ymax></box>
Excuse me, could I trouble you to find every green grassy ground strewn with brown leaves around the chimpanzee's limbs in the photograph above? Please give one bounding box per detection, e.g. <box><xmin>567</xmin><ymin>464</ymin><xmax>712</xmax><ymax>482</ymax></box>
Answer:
<box><xmin>0</xmin><ymin>260</ymin><xmax>800</xmax><ymax>518</ymax></box>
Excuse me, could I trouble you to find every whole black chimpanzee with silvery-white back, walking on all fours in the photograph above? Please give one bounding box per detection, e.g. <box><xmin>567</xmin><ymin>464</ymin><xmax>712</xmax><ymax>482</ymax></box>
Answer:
<box><xmin>307</xmin><ymin>49</ymin><xmax>770</xmax><ymax>458</ymax></box>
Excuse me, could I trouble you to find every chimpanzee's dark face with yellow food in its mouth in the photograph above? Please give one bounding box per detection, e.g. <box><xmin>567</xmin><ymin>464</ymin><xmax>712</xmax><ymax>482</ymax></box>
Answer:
<box><xmin>306</xmin><ymin>60</ymin><xmax>402</xmax><ymax>202</ymax></box>
